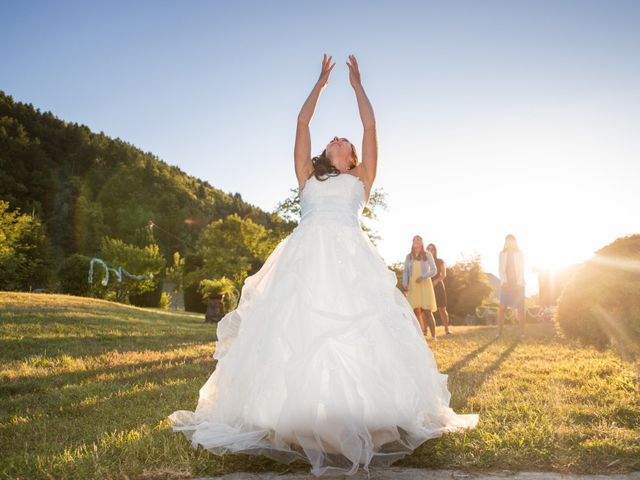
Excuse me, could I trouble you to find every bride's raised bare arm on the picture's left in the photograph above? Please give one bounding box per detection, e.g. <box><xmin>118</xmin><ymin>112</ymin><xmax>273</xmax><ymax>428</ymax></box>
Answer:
<box><xmin>293</xmin><ymin>54</ymin><xmax>336</xmax><ymax>188</ymax></box>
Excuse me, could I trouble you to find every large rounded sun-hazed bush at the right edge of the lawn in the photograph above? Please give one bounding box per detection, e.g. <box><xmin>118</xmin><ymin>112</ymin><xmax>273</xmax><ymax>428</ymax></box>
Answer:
<box><xmin>557</xmin><ymin>235</ymin><xmax>640</xmax><ymax>349</ymax></box>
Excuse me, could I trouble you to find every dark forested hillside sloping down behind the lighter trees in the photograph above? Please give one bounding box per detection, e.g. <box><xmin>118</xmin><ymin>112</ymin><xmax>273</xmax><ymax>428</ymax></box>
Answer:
<box><xmin>0</xmin><ymin>91</ymin><xmax>281</xmax><ymax>259</ymax></box>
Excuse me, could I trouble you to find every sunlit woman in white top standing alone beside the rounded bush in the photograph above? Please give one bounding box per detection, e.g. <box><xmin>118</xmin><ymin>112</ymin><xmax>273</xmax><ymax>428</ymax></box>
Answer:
<box><xmin>496</xmin><ymin>234</ymin><xmax>525</xmax><ymax>337</ymax></box>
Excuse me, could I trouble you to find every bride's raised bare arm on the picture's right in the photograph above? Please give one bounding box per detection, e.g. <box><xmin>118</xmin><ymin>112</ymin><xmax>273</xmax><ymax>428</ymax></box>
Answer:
<box><xmin>347</xmin><ymin>55</ymin><xmax>378</xmax><ymax>188</ymax></box>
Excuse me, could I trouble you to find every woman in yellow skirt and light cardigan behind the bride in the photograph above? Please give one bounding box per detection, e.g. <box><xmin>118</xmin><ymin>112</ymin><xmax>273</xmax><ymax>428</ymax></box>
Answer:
<box><xmin>402</xmin><ymin>235</ymin><xmax>438</xmax><ymax>340</ymax></box>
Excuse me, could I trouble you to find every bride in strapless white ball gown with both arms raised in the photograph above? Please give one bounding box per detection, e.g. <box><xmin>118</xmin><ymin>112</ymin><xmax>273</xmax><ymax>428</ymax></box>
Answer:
<box><xmin>169</xmin><ymin>55</ymin><xmax>478</xmax><ymax>476</ymax></box>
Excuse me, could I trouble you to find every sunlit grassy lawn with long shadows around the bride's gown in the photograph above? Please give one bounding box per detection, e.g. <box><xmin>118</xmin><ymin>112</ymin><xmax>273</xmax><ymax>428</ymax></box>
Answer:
<box><xmin>0</xmin><ymin>292</ymin><xmax>640</xmax><ymax>479</ymax></box>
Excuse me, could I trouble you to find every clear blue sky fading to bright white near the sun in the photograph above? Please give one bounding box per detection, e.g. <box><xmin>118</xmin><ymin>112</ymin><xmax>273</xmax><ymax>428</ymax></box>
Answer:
<box><xmin>0</xmin><ymin>0</ymin><xmax>640</xmax><ymax>292</ymax></box>
